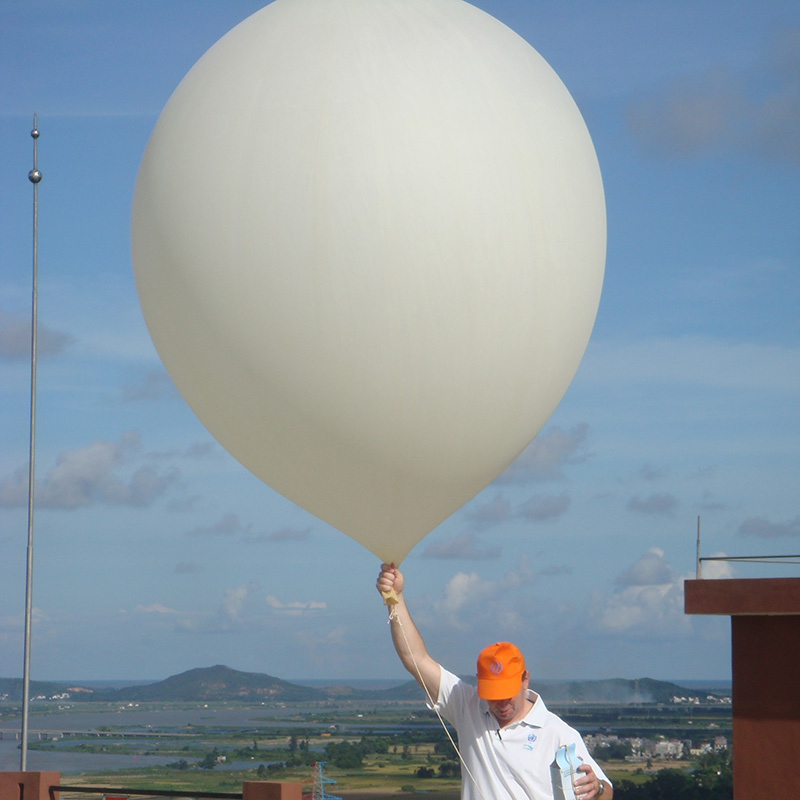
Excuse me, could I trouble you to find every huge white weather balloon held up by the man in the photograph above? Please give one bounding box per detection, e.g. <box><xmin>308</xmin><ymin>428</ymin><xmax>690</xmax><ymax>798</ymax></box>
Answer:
<box><xmin>132</xmin><ymin>0</ymin><xmax>605</xmax><ymax>563</ymax></box>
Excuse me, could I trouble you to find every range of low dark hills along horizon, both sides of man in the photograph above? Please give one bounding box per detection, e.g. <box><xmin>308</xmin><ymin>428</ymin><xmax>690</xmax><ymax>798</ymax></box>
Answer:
<box><xmin>0</xmin><ymin>665</ymin><xmax>720</xmax><ymax>704</ymax></box>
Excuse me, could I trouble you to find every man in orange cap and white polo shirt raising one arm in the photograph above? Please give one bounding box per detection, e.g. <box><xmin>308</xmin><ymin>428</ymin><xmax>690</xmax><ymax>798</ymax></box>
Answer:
<box><xmin>377</xmin><ymin>564</ymin><xmax>613</xmax><ymax>800</ymax></box>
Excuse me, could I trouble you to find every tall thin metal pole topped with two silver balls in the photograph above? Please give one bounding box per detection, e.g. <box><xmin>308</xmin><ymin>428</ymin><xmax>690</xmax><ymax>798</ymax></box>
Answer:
<box><xmin>20</xmin><ymin>114</ymin><xmax>42</xmax><ymax>772</ymax></box>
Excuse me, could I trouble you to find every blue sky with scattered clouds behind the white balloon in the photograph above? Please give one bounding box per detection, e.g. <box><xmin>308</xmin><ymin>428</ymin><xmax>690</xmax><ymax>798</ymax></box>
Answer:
<box><xmin>0</xmin><ymin>0</ymin><xmax>800</xmax><ymax>685</ymax></box>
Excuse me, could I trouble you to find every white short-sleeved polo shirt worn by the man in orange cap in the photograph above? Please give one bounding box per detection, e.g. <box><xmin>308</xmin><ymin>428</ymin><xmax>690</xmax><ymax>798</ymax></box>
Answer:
<box><xmin>436</xmin><ymin>668</ymin><xmax>610</xmax><ymax>800</ymax></box>
